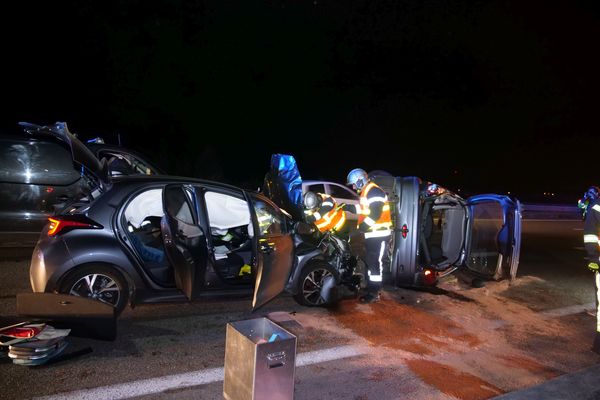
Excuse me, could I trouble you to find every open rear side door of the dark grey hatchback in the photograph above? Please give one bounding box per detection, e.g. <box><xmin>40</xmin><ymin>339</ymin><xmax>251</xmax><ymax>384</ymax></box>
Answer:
<box><xmin>160</xmin><ymin>184</ymin><xmax>208</xmax><ymax>300</ymax></box>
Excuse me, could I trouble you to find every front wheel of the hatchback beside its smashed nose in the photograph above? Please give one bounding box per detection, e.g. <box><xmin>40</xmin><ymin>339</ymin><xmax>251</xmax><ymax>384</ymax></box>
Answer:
<box><xmin>294</xmin><ymin>261</ymin><xmax>339</xmax><ymax>307</ymax></box>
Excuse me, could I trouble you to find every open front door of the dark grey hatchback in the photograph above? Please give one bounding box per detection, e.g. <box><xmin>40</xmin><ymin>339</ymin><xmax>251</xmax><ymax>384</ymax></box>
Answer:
<box><xmin>250</xmin><ymin>195</ymin><xmax>294</xmax><ymax>310</ymax></box>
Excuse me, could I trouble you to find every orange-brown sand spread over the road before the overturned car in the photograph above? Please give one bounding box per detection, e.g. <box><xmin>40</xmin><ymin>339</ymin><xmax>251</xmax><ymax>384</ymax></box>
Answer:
<box><xmin>330</xmin><ymin>277</ymin><xmax>598</xmax><ymax>400</ymax></box>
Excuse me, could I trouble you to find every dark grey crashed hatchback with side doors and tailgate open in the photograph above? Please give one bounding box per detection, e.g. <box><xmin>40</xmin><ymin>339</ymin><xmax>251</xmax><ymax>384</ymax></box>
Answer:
<box><xmin>30</xmin><ymin>139</ymin><xmax>359</xmax><ymax>312</ymax></box>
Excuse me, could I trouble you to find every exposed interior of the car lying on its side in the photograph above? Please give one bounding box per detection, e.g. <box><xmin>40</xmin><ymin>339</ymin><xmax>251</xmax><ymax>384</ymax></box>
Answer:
<box><xmin>420</xmin><ymin>195</ymin><xmax>466</xmax><ymax>270</ymax></box>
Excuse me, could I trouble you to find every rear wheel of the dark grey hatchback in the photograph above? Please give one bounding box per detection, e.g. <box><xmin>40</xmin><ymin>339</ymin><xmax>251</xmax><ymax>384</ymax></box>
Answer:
<box><xmin>59</xmin><ymin>265</ymin><xmax>129</xmax><ymax>315</ymax></box>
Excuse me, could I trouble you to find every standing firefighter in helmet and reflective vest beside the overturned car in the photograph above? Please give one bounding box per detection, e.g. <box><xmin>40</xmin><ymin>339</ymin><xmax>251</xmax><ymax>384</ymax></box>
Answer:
<box><xmin>346</xmin><ymin>168</ymin><xmax>392</xmax><ymax>303</ymax></box>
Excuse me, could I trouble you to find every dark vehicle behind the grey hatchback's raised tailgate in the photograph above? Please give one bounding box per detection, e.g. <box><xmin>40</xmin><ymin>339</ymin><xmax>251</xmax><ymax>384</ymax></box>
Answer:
<box><xmin>0</xmin><ymin>122</ymin><xmax>160</xmax><ymax>247</ymax></box>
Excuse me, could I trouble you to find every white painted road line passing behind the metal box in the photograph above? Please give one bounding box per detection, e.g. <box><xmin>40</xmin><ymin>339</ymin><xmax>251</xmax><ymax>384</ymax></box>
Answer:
<box><xmin>35</xmin><ymin>346</ymin><xmax>364</xmax><ymax>400</ymax></box>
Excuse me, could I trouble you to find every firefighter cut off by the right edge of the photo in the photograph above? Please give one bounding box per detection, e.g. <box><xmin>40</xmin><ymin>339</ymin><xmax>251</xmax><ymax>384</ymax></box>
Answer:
<box><xmin>578</xmin><ymin>186</ymin><xmax>600</xmax><ymax>354</ymax></box>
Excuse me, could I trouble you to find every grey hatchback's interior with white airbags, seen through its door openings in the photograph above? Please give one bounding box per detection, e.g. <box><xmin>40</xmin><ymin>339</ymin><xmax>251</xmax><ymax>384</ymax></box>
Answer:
<box><xmin>124</xmin><ymin>188</ymin><xmax>255</xmax><ymax>286</ymax></box>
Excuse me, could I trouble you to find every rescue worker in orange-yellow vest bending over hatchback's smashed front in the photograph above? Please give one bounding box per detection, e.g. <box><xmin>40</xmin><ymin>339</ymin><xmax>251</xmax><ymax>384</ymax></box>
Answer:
<box><xmin>304</xmin><ymin>192</ymin><xmax>346</xmax><ymax>234</ymax></box>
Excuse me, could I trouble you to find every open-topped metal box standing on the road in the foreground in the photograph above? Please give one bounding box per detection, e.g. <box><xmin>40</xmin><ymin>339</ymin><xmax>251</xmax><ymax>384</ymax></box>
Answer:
<box><xmin>223</xmin><ymin>318</ymin><xmax>296</xmax><ymax>400</ymax></box>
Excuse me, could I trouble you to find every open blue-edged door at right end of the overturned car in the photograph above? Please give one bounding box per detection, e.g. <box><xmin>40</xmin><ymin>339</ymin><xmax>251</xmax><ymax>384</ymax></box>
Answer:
<box><xmin>464</xmin><ymin>194</ymin><xmax>521</xmax><ymax>280</ymax></box>
